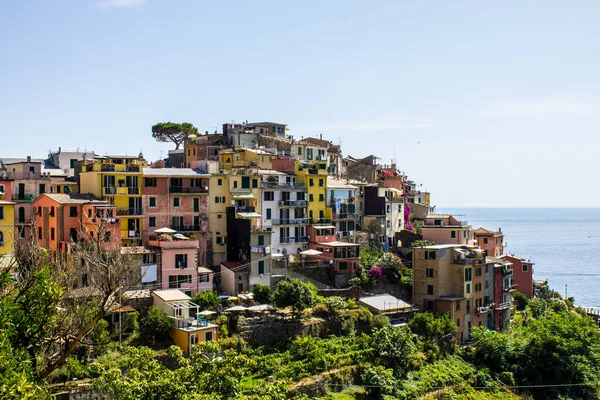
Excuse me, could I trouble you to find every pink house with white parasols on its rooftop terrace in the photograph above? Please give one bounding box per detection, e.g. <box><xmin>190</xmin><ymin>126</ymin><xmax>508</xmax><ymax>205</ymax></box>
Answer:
<box><xmin>148</xmin><ymin>234</ymin><xmax>213</xmax><ymax>296</ymax></box>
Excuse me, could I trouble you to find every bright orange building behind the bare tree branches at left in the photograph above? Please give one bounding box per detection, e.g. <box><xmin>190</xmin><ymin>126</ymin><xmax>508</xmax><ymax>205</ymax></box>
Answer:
<box><xmin>33</xmin><ymin>193</ymin><xmax>121</xmax><ymax>252</ymax></box>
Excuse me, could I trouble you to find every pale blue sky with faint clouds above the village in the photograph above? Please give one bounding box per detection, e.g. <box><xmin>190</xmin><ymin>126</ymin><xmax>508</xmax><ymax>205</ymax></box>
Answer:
<box><xmin>0</xmin><ymin>0</ymin><xmax>600</xmax><ymax>207</ymax></box>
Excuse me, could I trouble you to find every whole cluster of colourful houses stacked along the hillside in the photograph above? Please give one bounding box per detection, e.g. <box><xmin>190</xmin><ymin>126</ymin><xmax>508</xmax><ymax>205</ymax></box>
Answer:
<box><xmin>0</xmin><ymin>122</ymin><xmax>533</xmax><ymax>340</ymax></box>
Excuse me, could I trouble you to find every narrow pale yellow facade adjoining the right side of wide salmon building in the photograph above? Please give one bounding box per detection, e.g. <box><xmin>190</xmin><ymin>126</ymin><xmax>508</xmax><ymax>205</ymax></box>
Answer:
<box><xmin>208</xmin><ymin>173</ymin><xmax>231</xmax><ymax>266</ymax></box>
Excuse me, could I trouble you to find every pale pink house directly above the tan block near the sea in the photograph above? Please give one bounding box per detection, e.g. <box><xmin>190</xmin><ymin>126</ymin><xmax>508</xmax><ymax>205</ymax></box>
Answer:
<box><xmin>420</xmin><ymin>214</ymin><xmax>474</xmax><ymax>246</ymax></box>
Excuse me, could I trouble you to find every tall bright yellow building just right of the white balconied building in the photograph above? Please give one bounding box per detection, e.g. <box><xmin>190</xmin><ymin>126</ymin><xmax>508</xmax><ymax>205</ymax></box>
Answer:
<box><xmin>296</xmin><ymin>160</ymin><xmax>332</xmax><ymax>224</ymax></box>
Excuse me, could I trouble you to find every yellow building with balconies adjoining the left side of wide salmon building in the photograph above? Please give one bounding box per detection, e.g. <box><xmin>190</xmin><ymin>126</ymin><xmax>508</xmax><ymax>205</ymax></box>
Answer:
<box><xmin>79</xmin><ymin>154</ymin><xmax>147</xmax><ymax>246</ymax></box>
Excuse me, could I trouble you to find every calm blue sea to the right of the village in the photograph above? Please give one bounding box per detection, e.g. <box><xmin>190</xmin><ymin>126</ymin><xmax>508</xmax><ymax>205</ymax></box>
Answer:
<box><xmin>436</xmin><ymin>207</ymin><xmax>600</xmax><ymax>308</ymax></box>
